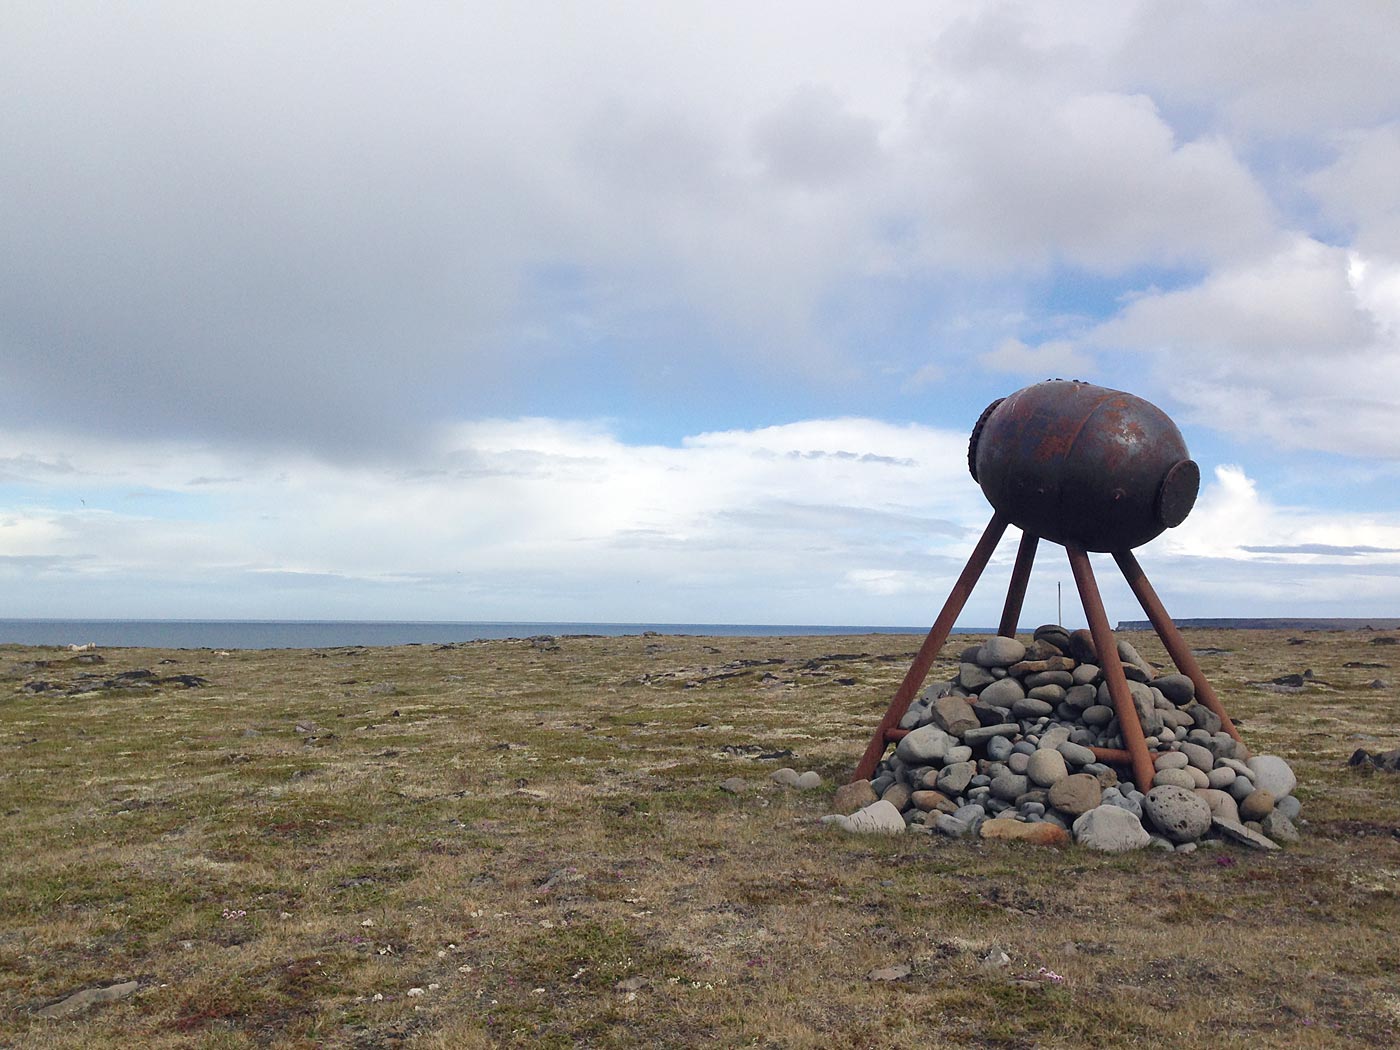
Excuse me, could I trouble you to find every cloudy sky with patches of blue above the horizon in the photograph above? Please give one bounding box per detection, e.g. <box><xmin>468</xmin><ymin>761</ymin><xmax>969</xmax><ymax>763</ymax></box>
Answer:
<box><xmin>0</xmin><ymin>0</ymin><xmax>1400</xmax><ymax>626</ymax></box>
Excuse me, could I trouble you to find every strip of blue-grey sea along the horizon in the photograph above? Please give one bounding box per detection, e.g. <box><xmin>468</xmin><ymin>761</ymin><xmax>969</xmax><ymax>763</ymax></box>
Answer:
<box><xmin>0</xmin><ymin>619</ymin><xmax>995</xmax><ymax>650</ymax></box>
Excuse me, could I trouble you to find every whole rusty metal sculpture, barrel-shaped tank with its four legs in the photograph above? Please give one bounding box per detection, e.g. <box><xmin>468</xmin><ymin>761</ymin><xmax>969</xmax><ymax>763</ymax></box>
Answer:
<box><xmin>854</xmin><ymin>379</ymin><xmax>1239</xmax><ymax>791</ymax></box>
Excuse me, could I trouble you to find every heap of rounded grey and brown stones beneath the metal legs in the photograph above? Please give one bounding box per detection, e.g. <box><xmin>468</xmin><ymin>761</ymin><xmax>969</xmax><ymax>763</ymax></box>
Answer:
<box><xmin>829</xmin><ymin>624</ymin><xmax>1299</xmax><ymax>853</ymax></box>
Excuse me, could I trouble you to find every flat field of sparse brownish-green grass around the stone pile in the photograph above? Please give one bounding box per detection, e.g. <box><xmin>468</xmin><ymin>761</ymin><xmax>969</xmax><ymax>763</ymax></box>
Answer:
<box><xmin>0</xmin><ymin>631</ymin><xmax>1400</xmax><ymax>1047</ymax></box>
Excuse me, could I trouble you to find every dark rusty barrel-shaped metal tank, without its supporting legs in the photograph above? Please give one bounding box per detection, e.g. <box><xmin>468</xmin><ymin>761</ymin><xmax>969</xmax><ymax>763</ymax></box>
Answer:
<box><xmin>967</xmin><ymin>379</ymin><xmax>1201</xmax><ymax>552</ymax></box>
